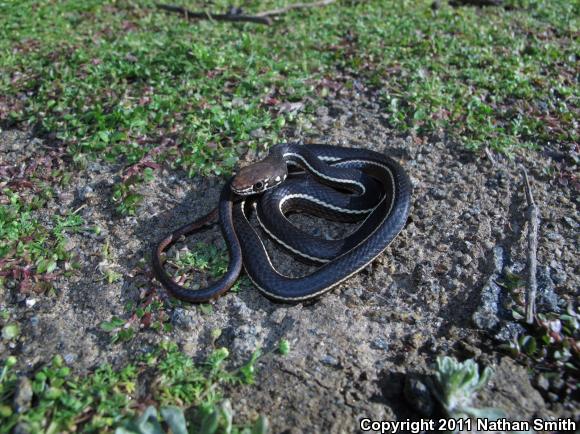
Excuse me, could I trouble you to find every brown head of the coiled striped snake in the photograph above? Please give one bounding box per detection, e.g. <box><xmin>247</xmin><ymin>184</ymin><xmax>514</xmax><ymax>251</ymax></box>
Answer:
<box><xmin>232</xmin><ymin>159</ymin><xmax>287</xmax><ymax>196</ymax></box>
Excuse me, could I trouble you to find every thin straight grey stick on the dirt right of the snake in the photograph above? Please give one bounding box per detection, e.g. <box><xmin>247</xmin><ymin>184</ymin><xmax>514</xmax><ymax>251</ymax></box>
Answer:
<box><xmin>522</xmin><ymin>167</ymin><xmax>540</xmax><ymax>324</ymax></box>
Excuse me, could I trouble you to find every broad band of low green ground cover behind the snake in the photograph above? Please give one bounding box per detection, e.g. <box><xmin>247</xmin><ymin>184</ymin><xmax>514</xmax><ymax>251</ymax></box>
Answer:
<box><xmin>0</xmin><ymin>0</ymin><xmax>579</xmax><ymax>164</ymax></box>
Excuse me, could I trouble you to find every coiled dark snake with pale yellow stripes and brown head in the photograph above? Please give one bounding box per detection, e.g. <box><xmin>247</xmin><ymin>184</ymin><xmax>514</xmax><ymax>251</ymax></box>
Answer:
<box><xmin>152</xmin><ymin>143</ymin><xmax>412</xmax><ymax>303</ymax></box>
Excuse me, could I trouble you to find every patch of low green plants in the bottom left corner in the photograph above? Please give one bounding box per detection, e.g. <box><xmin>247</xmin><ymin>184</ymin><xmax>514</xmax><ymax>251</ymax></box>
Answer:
<box><xmin>0</xmin><ymin>343</ymin><xmax>267</xmax><ymax>434</ymax></box>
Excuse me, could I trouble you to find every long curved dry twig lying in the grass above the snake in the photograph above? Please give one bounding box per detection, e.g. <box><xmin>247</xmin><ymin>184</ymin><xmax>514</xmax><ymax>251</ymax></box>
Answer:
<box><xmin>156</xmin><ymin>0</ymin><xmax>336</xmax><ymax>26</ymax></box>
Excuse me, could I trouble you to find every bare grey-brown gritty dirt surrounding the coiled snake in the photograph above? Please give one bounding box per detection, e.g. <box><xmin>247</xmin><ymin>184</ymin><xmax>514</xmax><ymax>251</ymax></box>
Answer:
<box><xmin>0</xmin><ymin>84</ymin><xmax>580</xmax><ymax>433</ymax></box>
